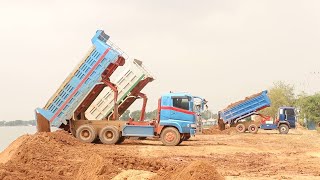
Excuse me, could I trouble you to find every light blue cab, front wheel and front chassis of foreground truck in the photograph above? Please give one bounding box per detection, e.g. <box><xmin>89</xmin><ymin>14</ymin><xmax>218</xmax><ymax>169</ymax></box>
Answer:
<box><xmin>122</xmin><ymin>93</ymin><xmax>206</xmax><ymax>146</ymax></box>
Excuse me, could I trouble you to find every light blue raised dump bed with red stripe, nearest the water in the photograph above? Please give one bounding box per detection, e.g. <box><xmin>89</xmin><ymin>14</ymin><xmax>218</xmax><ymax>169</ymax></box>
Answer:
<box><xmin>36</xmin><ymin>30</ymin><xmax>124</xmax><ymax>127</ymax></box>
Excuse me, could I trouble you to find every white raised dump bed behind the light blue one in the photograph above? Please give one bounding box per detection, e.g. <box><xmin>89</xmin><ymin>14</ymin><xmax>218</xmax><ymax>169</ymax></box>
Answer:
<box><xmin>85</xmin><ymin>60</ymin><xmax>153</xmax><ymax>120</ymax></box>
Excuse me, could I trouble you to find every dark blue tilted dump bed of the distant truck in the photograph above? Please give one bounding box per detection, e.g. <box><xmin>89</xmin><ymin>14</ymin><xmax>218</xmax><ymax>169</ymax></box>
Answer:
<box><xmin>219</xmin><ymin>91</ymin><xmax>270</xmax><ymax>124</ymax></box>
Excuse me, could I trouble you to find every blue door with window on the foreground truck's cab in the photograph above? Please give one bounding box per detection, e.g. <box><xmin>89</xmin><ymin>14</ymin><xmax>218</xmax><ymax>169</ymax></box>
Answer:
<box><xmin>170</xmin><ymin>96</ymin><xmax>195</xmax><ymax>121</ymax></box>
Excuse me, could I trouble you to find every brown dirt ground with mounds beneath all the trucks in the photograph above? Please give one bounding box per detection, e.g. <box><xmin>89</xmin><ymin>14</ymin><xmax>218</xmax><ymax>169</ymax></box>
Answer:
<box><xmin>0</xmin><ymin>125</ymin><xmax>320</xmax><ymax>180</ymax></box>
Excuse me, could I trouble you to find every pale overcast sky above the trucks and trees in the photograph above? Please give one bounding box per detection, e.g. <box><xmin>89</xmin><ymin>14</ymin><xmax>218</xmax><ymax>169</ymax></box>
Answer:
<box><xmin>0</xmin><ymin>0</ymin><xmax>320</xmax><ymax>121</ymax></box>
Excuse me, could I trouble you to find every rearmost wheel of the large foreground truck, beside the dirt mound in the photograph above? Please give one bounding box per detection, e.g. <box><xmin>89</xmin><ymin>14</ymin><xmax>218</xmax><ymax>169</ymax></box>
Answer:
<box><xmin>76</xmin><ymin>124</ymin><xmax>97</xmax><ymax>143</ymax></box>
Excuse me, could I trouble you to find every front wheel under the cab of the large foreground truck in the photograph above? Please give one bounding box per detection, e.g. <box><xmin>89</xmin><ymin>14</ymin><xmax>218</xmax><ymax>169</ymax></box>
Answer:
<box><xmin>160</xmin><ymin>127</ymin><xmax>181</xmax><ymax>146</ymax></box>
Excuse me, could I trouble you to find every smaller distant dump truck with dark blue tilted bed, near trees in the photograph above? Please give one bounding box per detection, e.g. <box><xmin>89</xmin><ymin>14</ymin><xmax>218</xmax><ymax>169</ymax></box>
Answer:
<box><xmin>218</xmin><ymin>90</ymin><xmax>296</xmax><ymax>134</ymax></box>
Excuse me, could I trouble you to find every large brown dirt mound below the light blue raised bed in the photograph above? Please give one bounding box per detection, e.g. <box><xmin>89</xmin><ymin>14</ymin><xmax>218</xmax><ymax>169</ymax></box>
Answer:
<box><xmin>0</xmin><ymin>131</ymin><xmax>178</xmax><ymax>179</ymax></box>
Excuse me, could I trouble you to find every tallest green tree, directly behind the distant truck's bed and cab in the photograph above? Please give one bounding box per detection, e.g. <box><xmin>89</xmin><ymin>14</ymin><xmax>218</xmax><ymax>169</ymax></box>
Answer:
<box><xmin>262</xmin><ymin>81</ymin><xmax>295</xmax><ymax>116</ymax></box>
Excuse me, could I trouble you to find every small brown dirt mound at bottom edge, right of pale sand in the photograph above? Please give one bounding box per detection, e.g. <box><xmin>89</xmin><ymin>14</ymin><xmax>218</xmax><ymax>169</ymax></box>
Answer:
<box><xmin>155</xmin><ymin>161</ymin><xmax>224</xmax><ymax>180</ymax></box>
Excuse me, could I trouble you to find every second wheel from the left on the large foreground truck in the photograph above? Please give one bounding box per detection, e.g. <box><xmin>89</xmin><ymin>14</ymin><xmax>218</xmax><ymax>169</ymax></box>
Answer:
<box><xmin>99</xmin><ymin>126</ymin><xmax>120</xmax><ymax>144</ymax></box>
